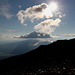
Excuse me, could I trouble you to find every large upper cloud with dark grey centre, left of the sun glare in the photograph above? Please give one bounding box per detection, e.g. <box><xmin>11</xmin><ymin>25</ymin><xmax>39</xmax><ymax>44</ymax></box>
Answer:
<box><xmin>17</xmin><ymin>3</ymin><xmax>52</xmax><ymax>24</ymax></box>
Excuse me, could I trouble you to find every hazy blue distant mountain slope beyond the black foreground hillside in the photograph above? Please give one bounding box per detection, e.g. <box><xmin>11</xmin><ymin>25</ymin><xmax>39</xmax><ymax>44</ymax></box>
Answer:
<box><xmin>0</xmin><ymin>39</ymin><xmax>50</xmax><ymax>60</ymax></box>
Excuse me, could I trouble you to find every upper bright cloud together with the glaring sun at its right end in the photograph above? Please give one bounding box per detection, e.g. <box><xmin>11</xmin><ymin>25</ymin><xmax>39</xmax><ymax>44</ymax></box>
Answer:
<box><xmin>17</xmin><ymin>2</ymin><xmax>58</xmax><ymax>24</ymax></box>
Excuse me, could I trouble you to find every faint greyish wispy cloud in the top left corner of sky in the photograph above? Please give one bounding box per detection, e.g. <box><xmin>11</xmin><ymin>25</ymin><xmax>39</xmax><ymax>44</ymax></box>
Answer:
<box><xmin>0</xmin><ymin>0</ymin><xmax>13</xmax><ymax>18</ymax></box>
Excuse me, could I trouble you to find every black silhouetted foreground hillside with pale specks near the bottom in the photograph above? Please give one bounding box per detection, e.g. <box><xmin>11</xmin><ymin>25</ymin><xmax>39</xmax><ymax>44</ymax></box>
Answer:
<box><xmin>0</xmin><ymin>39</ymin><xmax>75</xmax><ymax>75</ymax></box>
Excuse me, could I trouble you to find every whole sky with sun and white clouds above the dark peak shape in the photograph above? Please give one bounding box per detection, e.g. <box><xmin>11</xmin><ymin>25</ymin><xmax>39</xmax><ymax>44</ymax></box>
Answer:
<box><xmin>0</xmin><ymin>0</ymin><xmax>75</xmax><ymax>40</ymax></box>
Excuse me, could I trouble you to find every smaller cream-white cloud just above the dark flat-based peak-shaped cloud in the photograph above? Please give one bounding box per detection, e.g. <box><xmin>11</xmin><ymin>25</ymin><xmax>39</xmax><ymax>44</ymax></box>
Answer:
<box><xmin>34</xmin><ymin>19</ymin><xmax>61</xmax><ymax>34</ymax></box>
